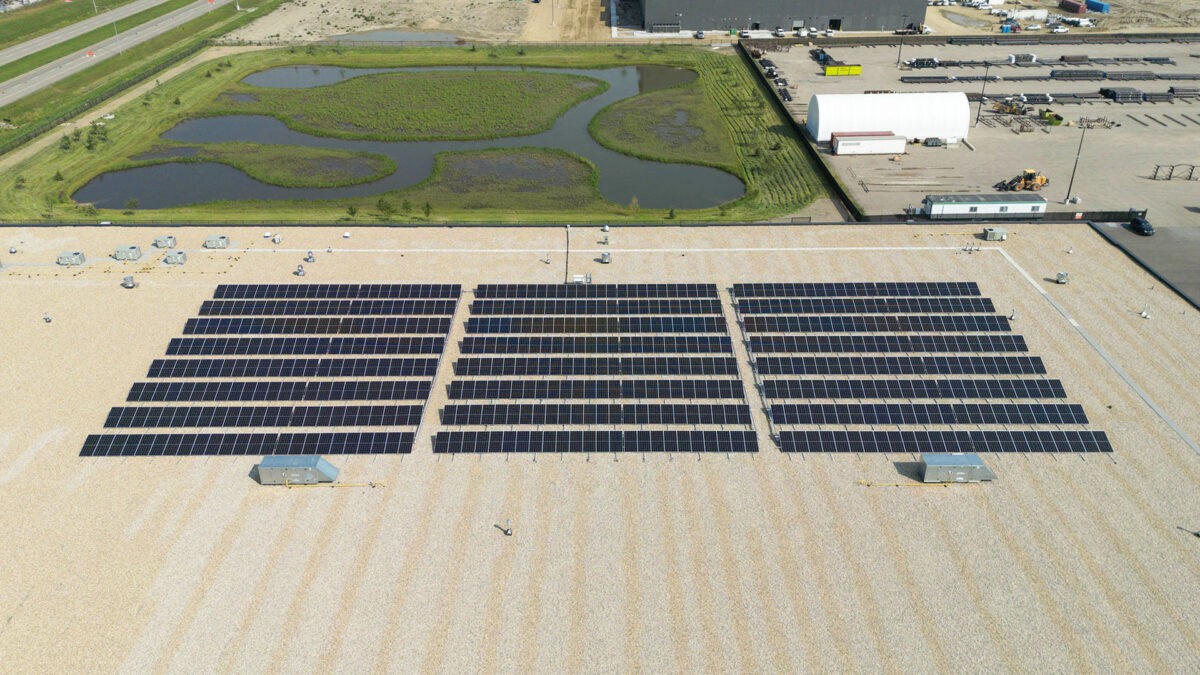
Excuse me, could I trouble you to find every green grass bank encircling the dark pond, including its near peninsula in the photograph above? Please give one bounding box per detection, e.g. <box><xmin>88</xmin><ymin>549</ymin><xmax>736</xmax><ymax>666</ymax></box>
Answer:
<box><xmin>0</xmin><ymin>46</ymin><xmax>827</xmax><ymax>222</ymax></box>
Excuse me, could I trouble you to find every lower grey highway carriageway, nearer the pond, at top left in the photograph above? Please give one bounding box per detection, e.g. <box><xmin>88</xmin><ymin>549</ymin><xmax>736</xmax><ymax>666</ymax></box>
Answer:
<box><xmin>0</xmin><ymin>0</ymin><xmax>234</xmax><ymax>107</ymax></box>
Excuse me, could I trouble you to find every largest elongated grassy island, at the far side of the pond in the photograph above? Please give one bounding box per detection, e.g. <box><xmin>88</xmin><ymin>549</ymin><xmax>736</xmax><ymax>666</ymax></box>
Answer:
<box><xmin>206</xmin><ymin>72</ymin><xmax>608</xmax><ymax>141</ymax></box>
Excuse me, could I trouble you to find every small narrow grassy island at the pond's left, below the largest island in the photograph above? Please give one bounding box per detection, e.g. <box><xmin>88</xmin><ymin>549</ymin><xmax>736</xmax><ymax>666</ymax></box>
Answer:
<box><xmin>128</xmin><ymin>143</ymin><xmax>396</xmax><ymax>187</ymax></box>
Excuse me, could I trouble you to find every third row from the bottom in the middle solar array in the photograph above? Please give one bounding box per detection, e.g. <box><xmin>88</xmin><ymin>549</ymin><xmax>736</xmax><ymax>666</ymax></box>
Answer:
<box><xmin>450</xmin><ymin>380</ymin><xmax>745</xmax><ymax>401</ymax></box>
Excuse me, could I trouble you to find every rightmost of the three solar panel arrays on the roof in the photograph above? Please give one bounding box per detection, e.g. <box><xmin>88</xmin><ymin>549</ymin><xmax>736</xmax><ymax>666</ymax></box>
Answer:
<box><xmin>733</xmin><ymin>282</ymin><xmax>1112</xmax><ymax>453</ymax></box>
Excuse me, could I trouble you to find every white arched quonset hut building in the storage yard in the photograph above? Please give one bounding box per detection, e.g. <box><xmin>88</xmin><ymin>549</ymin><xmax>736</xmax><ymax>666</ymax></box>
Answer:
<box><xmin>806</xmin><ymin>91</ymin><xmax>971</xmax><ymax>143</ymax></box>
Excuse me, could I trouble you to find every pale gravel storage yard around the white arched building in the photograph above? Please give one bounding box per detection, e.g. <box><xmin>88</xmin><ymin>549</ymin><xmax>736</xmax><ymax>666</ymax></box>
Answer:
<box><xmin>768</xmin><ymin>36</ymin><xmax>1200</xmax><ymax>297</ymax></box>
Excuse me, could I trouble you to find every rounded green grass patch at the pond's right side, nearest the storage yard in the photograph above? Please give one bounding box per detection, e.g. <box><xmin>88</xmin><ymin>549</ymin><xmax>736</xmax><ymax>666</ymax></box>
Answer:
<box><xmin>588</xmin><ymin>80</ymin><xmax>738</xmax><ymax>173</ymax></box>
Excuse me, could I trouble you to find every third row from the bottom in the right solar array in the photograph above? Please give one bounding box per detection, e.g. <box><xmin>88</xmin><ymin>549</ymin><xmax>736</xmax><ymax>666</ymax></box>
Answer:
<box><xmin>762</xmin><ymin>380</ymin><xmax>1067</xmax><ymax>399</ymax></box>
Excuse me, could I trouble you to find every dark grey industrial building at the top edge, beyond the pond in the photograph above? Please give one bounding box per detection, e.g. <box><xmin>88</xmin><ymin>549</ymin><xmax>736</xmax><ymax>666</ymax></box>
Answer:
<box><xmin>642</xmin><ymin>0</ymin><xmax>926</xmax><ymax>32</ymax></box>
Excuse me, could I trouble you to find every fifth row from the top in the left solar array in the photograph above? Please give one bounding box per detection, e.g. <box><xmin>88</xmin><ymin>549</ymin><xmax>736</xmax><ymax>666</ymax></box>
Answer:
<box><xmin>148</xmin><ymin>358</ymin><xmax>438</xmax><ymax>377</ymax></box>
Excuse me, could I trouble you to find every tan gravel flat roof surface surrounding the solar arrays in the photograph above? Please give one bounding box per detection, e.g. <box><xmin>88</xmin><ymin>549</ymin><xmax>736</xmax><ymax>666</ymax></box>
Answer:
<box><xmin>0</xmin><ymin>222</ymin><xmax>1200</xmax><ymax>673</ymax></box>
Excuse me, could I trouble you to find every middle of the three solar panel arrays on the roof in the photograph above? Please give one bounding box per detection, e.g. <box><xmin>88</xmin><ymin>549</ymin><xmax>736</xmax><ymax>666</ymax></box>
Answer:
<box><xmin>433</xmin><ymin>283</ymin><xmax>758</xmax><ymax>453</ymax></box>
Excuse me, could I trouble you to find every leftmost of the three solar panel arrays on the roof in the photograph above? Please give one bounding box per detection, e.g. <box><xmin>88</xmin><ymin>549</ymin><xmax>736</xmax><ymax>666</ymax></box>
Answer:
<box><xmin>80</xmin><ymin>283</ymin><xmax>462</xmax><ymax>456</ymax></box>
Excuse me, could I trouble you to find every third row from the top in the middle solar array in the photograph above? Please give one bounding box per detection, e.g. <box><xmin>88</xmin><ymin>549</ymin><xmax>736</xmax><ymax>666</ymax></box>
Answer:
<box><xmin>467</xmin><ymin>316</ymin><xmax>726</xmax><ymax>334</ymax></box>
